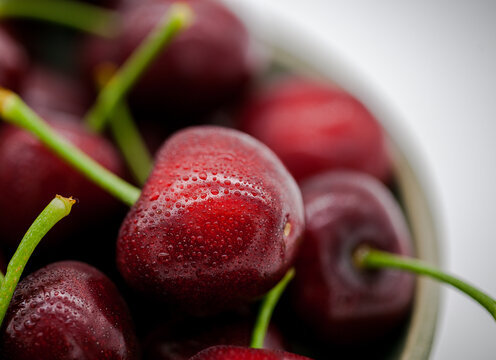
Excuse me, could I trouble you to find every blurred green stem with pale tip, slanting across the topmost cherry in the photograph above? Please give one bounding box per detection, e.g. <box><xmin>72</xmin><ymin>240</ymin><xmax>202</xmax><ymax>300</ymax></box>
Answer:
<box><xmin>85</xmin><ymin>3</ymin><xmax>193</xmax><ymax>132</ymax></box>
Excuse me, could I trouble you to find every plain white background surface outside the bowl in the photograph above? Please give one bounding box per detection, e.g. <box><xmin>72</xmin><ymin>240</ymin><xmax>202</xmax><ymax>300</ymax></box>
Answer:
<box><xmin>230</xmin><ymin>0</ymin><xmax>496</xmax><ymax>360</ymax></box>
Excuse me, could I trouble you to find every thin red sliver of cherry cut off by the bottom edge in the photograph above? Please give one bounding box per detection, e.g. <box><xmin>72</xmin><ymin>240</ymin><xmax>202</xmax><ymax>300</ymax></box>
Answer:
<box><xmin>190</xmin><ymin>346</ymin><xmax>311</xmax><ymax>360</ymax></box>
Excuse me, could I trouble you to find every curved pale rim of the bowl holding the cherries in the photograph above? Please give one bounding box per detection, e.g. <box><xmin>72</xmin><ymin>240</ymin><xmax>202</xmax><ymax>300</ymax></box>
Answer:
<box><xmin>227</xmin><ymin>0</ymin><xmax>440</xmax><ymax>360</ymax></box>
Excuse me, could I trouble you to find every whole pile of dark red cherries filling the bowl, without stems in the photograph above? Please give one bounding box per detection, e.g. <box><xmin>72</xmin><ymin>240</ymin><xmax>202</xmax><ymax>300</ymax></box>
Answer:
<box><xmin>0</xmin><ymin>0</ymin><xmax>492</xmax><ymax>360</ymax></box>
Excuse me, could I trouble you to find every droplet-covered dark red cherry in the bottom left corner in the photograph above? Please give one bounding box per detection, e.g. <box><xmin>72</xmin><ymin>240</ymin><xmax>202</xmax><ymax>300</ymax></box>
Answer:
<box><xmin>1</xmin><ymin>261</ymin><xmax>139</xmax><ymax>360</ymax></box>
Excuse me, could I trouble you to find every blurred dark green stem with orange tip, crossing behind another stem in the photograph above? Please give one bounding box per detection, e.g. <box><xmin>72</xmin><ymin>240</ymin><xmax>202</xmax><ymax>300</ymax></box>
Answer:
<box><xmin>96</xmin><ymin>63</ymin><xmax>153</xmax><ymax>185</ymax></box>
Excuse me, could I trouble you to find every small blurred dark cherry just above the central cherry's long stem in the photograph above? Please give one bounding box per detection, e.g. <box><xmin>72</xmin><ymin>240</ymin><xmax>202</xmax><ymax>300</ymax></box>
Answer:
<box><xmin>19</xmin><ymin>65</ymin><xmax>89</xmax><ymax>116</ymax></box>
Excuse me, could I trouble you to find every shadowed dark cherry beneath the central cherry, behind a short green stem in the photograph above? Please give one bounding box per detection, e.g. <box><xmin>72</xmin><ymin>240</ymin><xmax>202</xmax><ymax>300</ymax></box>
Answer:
<box><xmin>143</xmin><ymin>317</ymin><xmax>284</xmax><ymax>360</ymax></box>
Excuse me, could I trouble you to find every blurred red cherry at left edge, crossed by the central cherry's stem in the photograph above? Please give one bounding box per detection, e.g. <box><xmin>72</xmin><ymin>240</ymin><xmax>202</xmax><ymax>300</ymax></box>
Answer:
<box><xmin>0</xmin><ymin>112</ymin><xmax>124</xmax><ymax>246</ymax></box>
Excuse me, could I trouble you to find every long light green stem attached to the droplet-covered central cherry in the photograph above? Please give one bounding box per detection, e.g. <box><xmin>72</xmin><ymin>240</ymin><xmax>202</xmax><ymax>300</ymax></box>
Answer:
<box><xmin>0</xmin><ymin>87</ymin><xmax>141</xmax><ymax>206</ymax></box>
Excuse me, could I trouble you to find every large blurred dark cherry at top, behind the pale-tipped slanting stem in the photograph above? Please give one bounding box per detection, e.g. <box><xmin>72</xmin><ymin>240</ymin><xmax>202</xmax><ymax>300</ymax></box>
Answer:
<box><xmin>85</xmin><ymin>0</ymin><xmax>256</xmax><ymax>115</ymax></box>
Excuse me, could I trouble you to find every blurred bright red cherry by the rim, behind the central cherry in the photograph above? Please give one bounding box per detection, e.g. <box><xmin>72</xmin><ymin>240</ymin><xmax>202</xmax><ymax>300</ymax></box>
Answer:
<box><xmin>239</xmin><ymin>77</ymin><xmax>390</xmax><ymax>181</ymax></box>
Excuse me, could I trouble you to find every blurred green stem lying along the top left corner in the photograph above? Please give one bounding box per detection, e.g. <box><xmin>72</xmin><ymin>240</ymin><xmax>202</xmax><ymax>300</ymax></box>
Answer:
<box><xmin>0</xmin><ymin>0</ymin><xmax>119</xmax><ymax>37</ymax></box>
